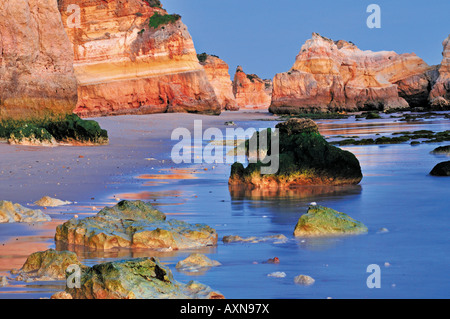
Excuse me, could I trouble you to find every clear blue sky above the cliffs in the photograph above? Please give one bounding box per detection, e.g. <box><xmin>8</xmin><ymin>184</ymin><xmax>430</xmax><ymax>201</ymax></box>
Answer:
<box><xmin>162</xmin><ymin>0</ymin><xmax>450</xmax><ymax>78</ymax></box>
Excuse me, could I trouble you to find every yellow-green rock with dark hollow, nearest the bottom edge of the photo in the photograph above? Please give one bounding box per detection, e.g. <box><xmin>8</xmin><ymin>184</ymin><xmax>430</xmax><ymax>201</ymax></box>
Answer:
<box><xmin>62</xmin><ymin>257</ymin><xmax>223</xmax><ymax>299</ymax></box>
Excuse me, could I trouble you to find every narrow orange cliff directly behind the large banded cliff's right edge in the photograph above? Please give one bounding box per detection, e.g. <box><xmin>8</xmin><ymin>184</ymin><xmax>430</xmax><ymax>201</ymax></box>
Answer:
<box><xmin>199</xmin><ymin>53</ymin><xmax>239</xmax><ymax>111</ymax></box>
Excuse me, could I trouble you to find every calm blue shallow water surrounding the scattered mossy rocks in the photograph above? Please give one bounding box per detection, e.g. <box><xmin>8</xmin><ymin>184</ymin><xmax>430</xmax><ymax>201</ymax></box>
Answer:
<box><xmin>0</xmin><ymin>112</ymin><xmax>450</xmax><ymax>299</ymax></box>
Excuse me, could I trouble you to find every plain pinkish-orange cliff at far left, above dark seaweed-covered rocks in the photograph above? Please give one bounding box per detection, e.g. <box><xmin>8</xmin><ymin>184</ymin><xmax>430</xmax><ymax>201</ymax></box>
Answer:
<box><xmin>0</xmin><ymin>0</ymin><xmax>77</xmax><ymax>120</ymax></box>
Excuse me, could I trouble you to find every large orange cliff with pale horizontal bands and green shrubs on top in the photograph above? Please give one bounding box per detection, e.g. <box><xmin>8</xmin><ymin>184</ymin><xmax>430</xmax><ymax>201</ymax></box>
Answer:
<box><xmin>59</xmin><ymin>0</ymin><xmax>220</xmax><ymax>116</ymax></box>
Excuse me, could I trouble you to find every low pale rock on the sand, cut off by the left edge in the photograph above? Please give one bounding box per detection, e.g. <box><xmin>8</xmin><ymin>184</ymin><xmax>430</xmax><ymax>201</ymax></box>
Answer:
<box><xmin>0</xmin><ymin>200</ymin><xmax>52</xmax><ymax>223</ymax></box>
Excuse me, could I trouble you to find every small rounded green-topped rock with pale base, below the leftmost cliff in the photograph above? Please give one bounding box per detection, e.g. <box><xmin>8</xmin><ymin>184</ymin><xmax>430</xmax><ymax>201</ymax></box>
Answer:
<box><xmin>8</xmin><ymin>124</ymin><xmax>57</xmax><ymax>146</ymax></box>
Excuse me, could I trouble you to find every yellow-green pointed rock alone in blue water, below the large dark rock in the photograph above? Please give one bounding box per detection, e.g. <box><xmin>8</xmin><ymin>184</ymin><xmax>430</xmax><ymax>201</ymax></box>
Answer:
<box><xmin>294</xmin><ymin>205</ymin><xmax>368</xmax><ymax>237</ymax></box>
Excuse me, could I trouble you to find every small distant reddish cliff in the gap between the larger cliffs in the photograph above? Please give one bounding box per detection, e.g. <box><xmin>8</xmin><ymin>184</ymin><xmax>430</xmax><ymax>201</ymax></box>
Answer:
<box><xmin>233</xmin><ymin>66</ymin><xmax>271</xmax><ymax>109</ymax></box>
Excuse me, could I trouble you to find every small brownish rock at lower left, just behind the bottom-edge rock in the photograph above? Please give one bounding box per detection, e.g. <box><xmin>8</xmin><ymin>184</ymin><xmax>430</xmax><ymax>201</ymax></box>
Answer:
<box><xmin>18</xmin><ymin>249</ymin><xmax>85</xmax><ymax>280</ymax></box>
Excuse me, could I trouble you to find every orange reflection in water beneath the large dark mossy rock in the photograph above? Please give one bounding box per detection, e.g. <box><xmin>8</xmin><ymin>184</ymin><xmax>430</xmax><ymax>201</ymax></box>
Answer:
<box><xmin>228</xmin><ymin>185</ymin><xmax>362</xmax><ymax>201</ymax></box>
